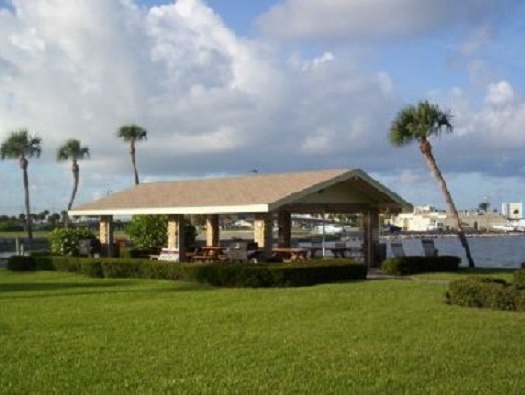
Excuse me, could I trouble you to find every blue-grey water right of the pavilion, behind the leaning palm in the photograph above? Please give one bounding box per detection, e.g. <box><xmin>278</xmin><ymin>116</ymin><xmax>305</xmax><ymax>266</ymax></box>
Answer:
<box><xmin>383</xmin><ymin>234</ymin><xmax>525</xmax><ymax>268</ymax></box>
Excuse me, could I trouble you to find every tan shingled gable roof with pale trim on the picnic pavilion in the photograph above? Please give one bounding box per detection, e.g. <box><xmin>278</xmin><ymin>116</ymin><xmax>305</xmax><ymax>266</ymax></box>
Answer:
<box><xmin>69</xmin><ymin>169</ymin><xmax>409</xmax><ymax>215</ymax></box>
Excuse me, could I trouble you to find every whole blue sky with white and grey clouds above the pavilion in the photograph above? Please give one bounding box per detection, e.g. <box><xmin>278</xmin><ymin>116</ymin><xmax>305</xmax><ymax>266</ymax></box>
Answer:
<box><xmin>0</xmin><ymin>0</ymin><xmax>525</xmax><ymax>214</ymax></box>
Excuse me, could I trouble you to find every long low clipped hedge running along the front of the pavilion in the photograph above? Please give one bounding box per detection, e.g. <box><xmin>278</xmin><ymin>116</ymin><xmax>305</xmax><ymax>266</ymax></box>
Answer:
<box><xmin>10</xmin><ymin>256</ymin><xmax>368</xmax><ymax>287</ymax></box>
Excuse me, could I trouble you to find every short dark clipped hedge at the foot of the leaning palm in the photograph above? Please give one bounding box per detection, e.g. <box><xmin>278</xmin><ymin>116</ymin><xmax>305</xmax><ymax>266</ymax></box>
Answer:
<box><xmin>381</xmin><ymin>255</ymin><xmax>461</xmax><ymax>276</ymax></box>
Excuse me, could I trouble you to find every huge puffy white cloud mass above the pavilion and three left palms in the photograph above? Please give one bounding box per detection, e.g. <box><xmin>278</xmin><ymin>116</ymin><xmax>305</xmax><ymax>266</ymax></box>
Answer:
<box><xmin>0</xmin><ymin>0</ymin><xmax>395</xmax><ymax>213</ymax></box>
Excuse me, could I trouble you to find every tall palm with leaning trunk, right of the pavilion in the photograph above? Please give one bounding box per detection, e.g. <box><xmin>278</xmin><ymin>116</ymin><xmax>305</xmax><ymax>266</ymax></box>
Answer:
<box><xmin>390</xmin><ymin>101</ymin><xmax>475</xmax><ymax>267</ymax></box>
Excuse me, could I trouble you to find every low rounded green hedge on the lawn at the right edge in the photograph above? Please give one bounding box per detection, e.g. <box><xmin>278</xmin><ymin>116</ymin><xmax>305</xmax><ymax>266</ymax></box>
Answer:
<box><xmin>446</xmin><ymin>277</ymin><xmax>525</xmax><ymax>311</ymax></box>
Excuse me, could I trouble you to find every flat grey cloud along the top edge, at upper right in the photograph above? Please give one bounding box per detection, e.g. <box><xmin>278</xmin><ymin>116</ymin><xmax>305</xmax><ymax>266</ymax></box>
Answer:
<box><xmin>259</xmin><ymin>0</ymin><xmax>520</xmax><ymax>43</ymax></box>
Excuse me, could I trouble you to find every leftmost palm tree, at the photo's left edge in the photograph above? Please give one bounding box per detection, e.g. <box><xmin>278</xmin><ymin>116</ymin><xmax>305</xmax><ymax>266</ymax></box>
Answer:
<box><xmin>0</xmin><ymin>129</ymin><xmax>42</xmax><ymax>244</ymax></box>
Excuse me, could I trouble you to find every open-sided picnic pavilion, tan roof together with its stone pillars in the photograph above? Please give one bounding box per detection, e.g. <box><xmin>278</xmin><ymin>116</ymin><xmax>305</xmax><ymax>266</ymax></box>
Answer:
<box><xmin>69</xmin><ymin>169</ymin><xmax>410</xmax><ymax>267</ymax></box>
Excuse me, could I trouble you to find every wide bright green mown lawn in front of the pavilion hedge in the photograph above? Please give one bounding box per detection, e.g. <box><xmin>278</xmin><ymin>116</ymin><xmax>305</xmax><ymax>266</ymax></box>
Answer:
<box><xmin>0</xmin><ymin>270</ymin><xmax>525</xmax><ymax>394</ymax></box>
